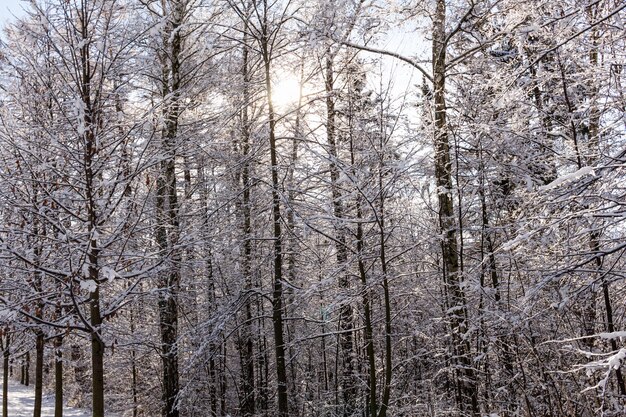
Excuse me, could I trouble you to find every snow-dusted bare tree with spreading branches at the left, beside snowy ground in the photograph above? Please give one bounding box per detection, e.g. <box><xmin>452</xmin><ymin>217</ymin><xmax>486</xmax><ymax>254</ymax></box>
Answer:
<box><xmin>3</xmin><ymin>1</ymin><xmax>150</xmax><ymax>416</ymax></box>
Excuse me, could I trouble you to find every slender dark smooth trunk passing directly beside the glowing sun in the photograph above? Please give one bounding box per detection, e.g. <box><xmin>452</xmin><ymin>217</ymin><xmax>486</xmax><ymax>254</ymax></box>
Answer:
<box><xmin>261</xmin><ymin>22</ymin><xmax>289</xmax><ymax>417</ymax></box>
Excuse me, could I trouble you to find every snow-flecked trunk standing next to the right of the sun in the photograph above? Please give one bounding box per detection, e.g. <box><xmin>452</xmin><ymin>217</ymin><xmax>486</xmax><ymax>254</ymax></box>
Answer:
<box><xmin>324</xmin><ymin>52</ymin><xmax>357</xmax><ymax>416</ymax></box>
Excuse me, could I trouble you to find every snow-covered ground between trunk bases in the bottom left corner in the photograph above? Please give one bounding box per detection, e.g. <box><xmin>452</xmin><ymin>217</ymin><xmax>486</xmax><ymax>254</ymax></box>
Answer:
<box><xmin>0</xmin><ymin>373</ymin><xmax>91</xmax><ymax>417</ymax></box>
